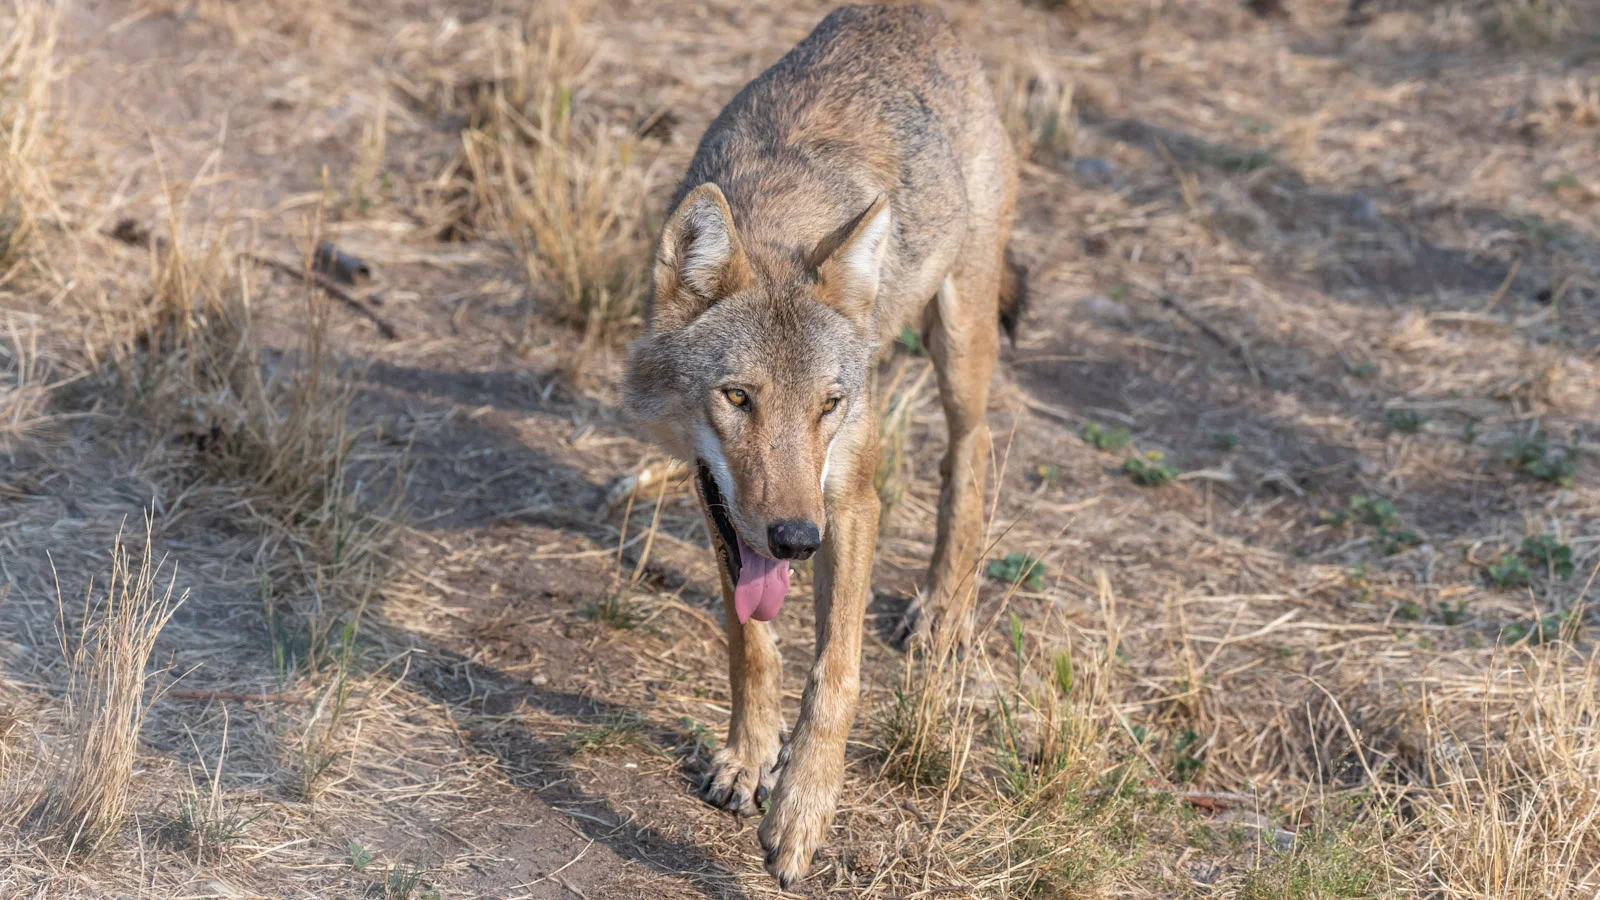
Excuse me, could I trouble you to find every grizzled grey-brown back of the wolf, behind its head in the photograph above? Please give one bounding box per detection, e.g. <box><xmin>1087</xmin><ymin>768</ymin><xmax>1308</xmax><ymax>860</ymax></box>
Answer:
<box><xmin>674</xmin><ymin>6</ymin><xmax>1014</xmax><ymax>335</ymax></box>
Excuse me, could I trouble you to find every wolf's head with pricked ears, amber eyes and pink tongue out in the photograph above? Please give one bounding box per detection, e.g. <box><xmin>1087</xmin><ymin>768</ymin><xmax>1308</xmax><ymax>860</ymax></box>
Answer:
<box><xmin>622</xmin><ymin>184</ymin><xmax>890</xmax><ymax>618</ymax></box>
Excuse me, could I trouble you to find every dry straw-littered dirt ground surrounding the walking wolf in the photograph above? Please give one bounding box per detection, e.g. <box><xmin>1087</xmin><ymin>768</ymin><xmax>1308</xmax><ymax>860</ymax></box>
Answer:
<box><xmin>0</xmin><ymin>0</ymin><xmax>1600</xmax><ymax>898</ymax></box>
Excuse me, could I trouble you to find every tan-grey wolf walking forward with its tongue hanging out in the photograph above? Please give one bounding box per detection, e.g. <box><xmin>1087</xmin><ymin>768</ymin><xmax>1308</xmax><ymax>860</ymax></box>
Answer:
<box><xmin>622</xmin><ymin>5</ymin><xmax>1024</xmax><ymax>889</ymax></box>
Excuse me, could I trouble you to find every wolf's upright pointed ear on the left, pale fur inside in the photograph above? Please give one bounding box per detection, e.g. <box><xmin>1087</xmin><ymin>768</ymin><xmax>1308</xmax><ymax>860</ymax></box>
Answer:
<box><xmin>650</xmin><ymin>181</ymin><xmax>752</xmax><ymax>333</ymax></box>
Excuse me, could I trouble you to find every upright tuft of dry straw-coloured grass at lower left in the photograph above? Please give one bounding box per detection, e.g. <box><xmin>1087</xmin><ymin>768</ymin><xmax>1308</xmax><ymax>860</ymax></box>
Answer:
<box><xmin>30</xmin><ymin>520</ymin><xmax>187</xmax><ymax>855</ymax></box>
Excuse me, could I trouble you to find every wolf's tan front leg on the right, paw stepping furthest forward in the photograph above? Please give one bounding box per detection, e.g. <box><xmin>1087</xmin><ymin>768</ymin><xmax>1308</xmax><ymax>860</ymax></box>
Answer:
<box><xmin>760</xmin><ymin>423</ymin><xmax>878</xmax><ymax>890</ymax></box>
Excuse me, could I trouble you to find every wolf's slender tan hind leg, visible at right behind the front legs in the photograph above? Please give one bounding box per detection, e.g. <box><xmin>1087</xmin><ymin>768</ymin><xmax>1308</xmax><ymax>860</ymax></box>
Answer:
<box><xmin>907</xmin><ymin>255</ymin><xmax>1000</xmax><ymax>641</ymax></box>
